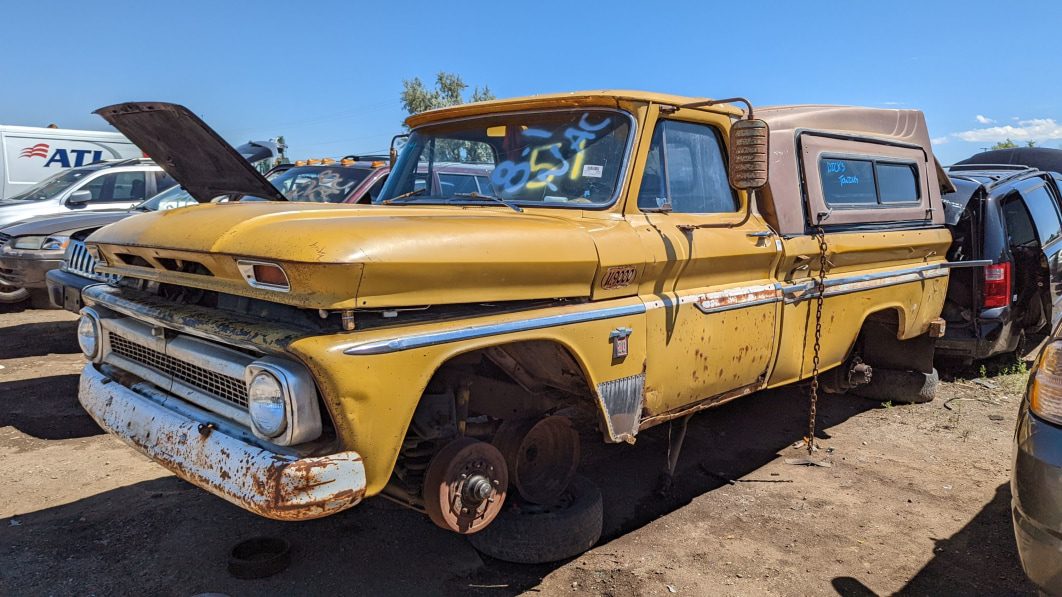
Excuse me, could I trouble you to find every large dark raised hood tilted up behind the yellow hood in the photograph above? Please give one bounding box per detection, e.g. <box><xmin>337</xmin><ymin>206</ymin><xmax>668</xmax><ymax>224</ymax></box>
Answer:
<box><xmin>95</xmin><ymin>102</ymin><xmax>286</xmax><ymax>203</ymax></box>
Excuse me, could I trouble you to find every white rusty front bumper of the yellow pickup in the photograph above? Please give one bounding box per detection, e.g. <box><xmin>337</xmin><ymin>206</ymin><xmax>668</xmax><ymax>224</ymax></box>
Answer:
<box><xmin>79</xmin><ymin>363</ymin><xmax>365</xmax><ymax>521</ymax></box>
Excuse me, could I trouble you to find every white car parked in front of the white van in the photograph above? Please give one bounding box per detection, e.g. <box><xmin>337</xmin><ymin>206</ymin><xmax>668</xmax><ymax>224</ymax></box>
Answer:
<box><xmin>0</xmin><ymin>157</ymin><xmax>176</xmax><ymax>226</ymax></box>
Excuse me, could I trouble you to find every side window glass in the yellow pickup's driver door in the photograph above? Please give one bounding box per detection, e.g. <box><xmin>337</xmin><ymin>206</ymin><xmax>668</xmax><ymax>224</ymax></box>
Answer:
<box><xmin>638</xmin><ymin>120</ymin><xmax>738</xmax><ymax>214</ymax></box>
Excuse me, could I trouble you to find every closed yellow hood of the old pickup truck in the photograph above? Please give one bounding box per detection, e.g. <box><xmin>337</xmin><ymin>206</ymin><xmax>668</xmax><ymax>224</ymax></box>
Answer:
<box><xmin>89</xmin><ymin>202</ymin><xmax>598</xmax><ymax>309</ymax></box>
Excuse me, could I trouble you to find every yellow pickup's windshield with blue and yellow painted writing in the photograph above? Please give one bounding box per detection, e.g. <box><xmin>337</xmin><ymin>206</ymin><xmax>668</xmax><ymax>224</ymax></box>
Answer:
<box><xmin>377</xmin><ymin>109</ymin><xmax>631</xmax><ymax>207</ymax></box>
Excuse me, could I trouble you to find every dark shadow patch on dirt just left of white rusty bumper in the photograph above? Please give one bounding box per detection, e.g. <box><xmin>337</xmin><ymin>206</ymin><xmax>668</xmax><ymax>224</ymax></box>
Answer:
<box><xmin>0</xmin><ymin>374</ymin><xmax>103</xmax><ymax>440</ymax></box>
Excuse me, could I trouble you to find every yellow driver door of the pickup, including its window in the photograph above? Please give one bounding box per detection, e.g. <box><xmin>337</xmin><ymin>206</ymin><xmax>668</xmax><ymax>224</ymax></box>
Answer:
<box><xmin>632</xmin><ymin>110</ymin><xmax>780</xmax><ymax>415</ymax></box>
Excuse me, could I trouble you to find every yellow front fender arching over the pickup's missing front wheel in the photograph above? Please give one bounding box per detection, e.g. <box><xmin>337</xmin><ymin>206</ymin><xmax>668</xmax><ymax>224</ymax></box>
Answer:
<box><xmin>288</xmin><ymin>299</ymin><xmax>646</xmax><ymax>495</ymax></box>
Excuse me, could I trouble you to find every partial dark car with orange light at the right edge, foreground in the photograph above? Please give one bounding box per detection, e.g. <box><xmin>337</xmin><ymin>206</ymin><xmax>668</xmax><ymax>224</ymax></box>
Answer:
<box><xmin>1010</xmin><ymin>327</ymin><xmax>1062</xmax><ymax>595</ymax></box>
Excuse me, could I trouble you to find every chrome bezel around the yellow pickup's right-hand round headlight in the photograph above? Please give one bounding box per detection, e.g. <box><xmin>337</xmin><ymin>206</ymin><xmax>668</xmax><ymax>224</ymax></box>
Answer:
<box><xmin>244</xmin><ymin>357</ymin><xmax>321</xmax><ymax>446</ymax></box>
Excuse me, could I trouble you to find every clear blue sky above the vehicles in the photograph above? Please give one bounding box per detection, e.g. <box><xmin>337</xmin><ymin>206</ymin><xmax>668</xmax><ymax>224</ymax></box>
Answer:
<box><xmin>0</xmin><ymin>0</ymin><xmax>1062</xmax><ymax>163</ymax></box>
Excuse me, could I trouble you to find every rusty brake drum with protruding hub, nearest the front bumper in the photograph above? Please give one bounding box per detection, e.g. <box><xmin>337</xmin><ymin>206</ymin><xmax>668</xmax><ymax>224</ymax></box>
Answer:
<box><xmin>424</xmin><ymin>438</ymin><xmax>509</xmax><ymax>534</ymax></box>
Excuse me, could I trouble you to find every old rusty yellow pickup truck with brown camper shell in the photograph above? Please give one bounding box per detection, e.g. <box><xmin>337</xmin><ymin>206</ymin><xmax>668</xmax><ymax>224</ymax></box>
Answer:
<box><xmin>78</xmin><ymin>91</ymin><xmax>950</xmax><ymax>561</ymax></box>
